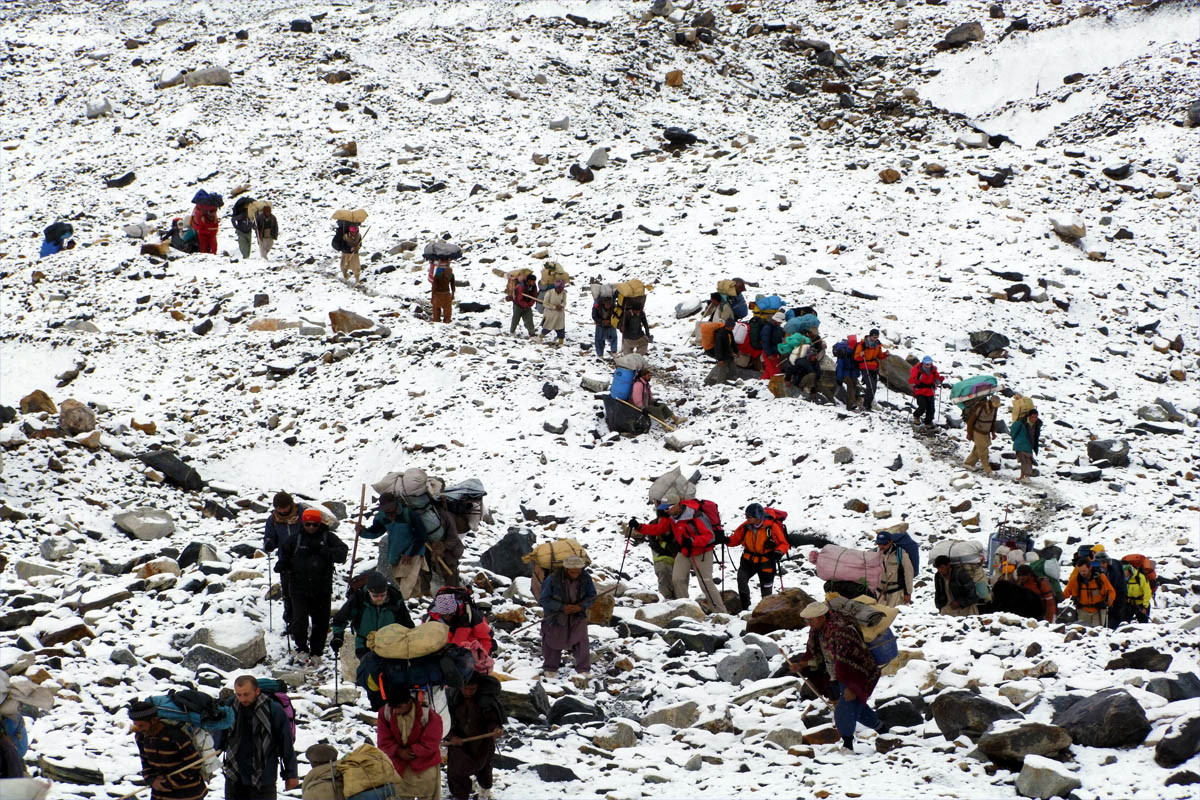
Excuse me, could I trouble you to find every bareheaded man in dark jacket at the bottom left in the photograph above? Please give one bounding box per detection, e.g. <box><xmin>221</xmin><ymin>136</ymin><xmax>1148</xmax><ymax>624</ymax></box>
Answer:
<box><xmin>212</xmin><ymin>675</ymin><xmax>300</xmax><ymax>800</ymax></box>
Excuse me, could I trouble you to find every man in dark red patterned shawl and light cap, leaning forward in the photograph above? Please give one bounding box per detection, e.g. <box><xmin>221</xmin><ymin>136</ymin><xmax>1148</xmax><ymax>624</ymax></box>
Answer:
<box><xmin>787</xmin><ymin>603</ymin><xmax>883</xmax><ymax>750</ymax></box>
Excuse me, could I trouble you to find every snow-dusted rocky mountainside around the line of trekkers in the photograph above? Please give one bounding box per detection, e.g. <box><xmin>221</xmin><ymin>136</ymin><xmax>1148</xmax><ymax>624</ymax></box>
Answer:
<box><xmin>0</xmin><ymin>0</ymin><xmax>1200</xmax><ymax>800</ymax></box>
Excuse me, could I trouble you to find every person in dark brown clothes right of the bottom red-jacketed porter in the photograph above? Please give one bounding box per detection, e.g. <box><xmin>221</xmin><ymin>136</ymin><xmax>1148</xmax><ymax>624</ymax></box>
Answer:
<box><xmin>446</xmin><ymin>672</ymin><xmax>508</xmax><ymax>800</ymax></box>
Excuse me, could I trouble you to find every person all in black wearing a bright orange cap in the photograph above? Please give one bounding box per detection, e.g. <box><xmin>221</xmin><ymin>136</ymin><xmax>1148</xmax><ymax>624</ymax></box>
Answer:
<box><xmin>275</xmin><ymin>509</ymin><xmax>349</xmax><ymax>663</ymax></box>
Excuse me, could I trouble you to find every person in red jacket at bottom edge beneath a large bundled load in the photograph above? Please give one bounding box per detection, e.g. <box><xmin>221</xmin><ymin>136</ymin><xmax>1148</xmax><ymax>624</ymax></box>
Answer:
<box><xmin>376</xmin><ymin>686</ymin><xmax>442</xmax><ymax>800</ymax></box>
